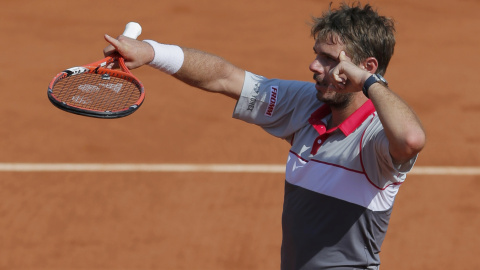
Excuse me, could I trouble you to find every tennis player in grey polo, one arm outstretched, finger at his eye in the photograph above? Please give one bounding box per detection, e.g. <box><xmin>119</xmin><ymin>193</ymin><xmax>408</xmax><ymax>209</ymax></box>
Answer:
<box><xmin>104</xmin><ymin>3</ymin><xmax>425</xmax><ymax>270</ymax></box>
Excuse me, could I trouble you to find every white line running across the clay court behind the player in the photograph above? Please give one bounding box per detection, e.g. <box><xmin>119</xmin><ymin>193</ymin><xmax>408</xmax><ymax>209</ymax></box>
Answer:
<box><xmin>0</xmin><ymin>163</ymin><xmax>480</xmax><ymax>175</ymax></box>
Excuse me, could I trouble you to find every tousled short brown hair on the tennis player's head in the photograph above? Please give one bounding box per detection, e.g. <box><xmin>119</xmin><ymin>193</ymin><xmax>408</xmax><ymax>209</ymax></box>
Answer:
<box><xmin>311</xmin><ymin>2</ymin><xmax>395</xmax><ymax>75</ymax></box>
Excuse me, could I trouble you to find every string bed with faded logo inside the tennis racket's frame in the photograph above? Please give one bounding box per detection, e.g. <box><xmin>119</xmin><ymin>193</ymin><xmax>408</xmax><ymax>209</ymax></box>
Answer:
<box><xmin>52</xmin><ymin>73</ymin><xmax>141</xmax><ymax>111</ymax></box>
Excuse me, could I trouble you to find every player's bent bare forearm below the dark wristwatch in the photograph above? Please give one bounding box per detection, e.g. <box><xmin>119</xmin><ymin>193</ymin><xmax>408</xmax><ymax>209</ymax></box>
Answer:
<box><xmin>368</xmin><ymin>83</ymin><xmax>425</xmax><ymax>164</ymax></box>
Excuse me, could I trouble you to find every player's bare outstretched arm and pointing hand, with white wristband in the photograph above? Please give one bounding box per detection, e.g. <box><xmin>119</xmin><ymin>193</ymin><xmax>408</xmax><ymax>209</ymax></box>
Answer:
<box><xmin>104</xmin><ymin>35</ymin><xmax>245</xmax><ymax>99</ymax></box>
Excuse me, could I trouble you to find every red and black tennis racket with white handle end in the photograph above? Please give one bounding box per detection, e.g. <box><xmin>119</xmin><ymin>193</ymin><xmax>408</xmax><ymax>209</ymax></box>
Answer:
<box><xmin>47</xmin><ymin>22</ymin><xmax>145</xmax><ymax>119</ymax></box>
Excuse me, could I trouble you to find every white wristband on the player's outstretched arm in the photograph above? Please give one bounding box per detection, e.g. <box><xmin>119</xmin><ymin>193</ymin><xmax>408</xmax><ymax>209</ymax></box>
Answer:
<box><xmin>144</xmin><ymin>39</ymin><xmax>185</xmax><ymax>75</ymax></box>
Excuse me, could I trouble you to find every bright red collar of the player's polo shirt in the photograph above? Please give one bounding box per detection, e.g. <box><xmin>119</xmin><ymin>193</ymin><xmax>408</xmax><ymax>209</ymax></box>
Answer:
<box><xmin>308</xmin><ymin>100</ymin><xmax>375</xmax><ymax>136</ymax></box>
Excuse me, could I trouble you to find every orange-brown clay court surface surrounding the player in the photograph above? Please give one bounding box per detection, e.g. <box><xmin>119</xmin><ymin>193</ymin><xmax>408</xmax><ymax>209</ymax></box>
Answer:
<box><xmin>0</xmin><ymin>0</ymin><xmax>480</xmax><ymax>270</ymax></box>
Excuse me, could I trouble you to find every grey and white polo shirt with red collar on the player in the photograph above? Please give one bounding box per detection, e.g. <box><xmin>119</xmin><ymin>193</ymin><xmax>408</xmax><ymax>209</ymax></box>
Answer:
<box><xmin>233</xmin><ymin>72</ymin><xmax>416</xmax><ymax>269</ymax></box>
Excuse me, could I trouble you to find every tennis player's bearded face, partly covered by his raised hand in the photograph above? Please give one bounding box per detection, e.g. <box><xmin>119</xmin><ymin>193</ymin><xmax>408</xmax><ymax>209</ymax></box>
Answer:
<box><xmin>309</xmin><ymin>38</ymin><xmax>353</xmax><ymax>109</ymax></box>
